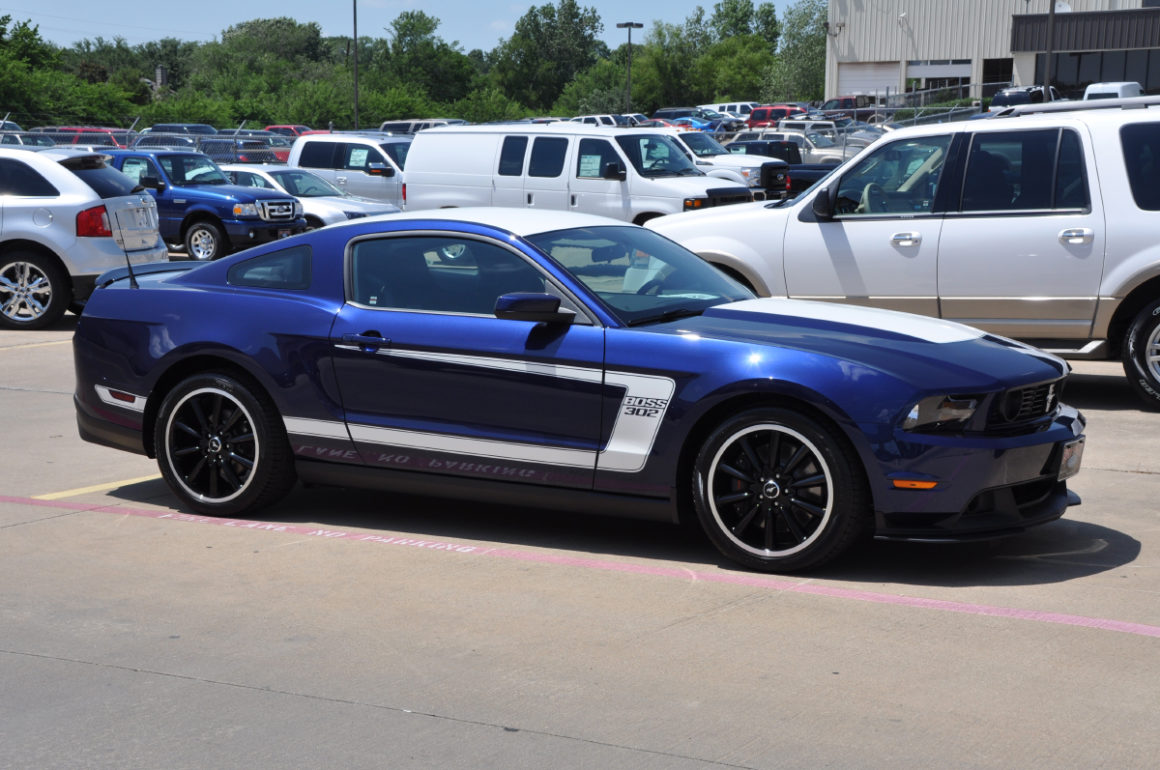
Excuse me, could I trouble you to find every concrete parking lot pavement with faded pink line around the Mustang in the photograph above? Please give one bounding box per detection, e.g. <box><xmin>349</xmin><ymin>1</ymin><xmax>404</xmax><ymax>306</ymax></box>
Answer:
<box><xmin>0</xmin><ymin>317</ymin><xmax>1160</xmax><ymax>769</ymax></box>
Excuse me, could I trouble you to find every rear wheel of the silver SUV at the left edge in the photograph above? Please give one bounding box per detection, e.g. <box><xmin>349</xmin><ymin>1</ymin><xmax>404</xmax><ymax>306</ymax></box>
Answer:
<box><xmin>0</xmin><ymin>252</ymin><xmax>72</xmax><ymax>329</ymax></box>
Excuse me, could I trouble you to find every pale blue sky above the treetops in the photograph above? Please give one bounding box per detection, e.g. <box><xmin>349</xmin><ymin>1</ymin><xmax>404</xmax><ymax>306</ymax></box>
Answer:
<box><xmin>0</xmin><ymin>0</ymin><xmax>792</xmax><ymax>52</ymax></box>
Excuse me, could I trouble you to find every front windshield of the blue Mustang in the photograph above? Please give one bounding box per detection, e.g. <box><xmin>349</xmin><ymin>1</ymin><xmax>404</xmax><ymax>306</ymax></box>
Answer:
<box><xmin>527</xmin><ymin>225</ymin><xmax>753</xmax><ymax>326</ymax></box>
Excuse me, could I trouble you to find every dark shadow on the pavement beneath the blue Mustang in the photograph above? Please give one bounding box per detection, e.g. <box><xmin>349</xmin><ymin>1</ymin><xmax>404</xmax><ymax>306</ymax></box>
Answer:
<box><xmin>104</xmin><ymin>481</ymin><xmax>1140</xmax><ymax>587</ymax></box>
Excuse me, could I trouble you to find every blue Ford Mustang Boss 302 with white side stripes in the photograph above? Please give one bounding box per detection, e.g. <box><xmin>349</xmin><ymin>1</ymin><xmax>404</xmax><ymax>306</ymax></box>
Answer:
<box><xmin>73</xmin><ymin>209</ymin><xmax>1083</xmax><ymax>572</ymax></box>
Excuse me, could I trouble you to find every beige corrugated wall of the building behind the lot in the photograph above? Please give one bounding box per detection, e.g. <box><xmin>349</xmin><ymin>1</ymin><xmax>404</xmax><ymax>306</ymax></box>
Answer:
<box><xmin>826</xmin><ymin>0</ymin><xmax>1141</xmax><ymax>99</ymax></box>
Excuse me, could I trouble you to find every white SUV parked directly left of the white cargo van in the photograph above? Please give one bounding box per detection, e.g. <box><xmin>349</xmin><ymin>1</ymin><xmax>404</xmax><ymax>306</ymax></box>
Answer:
<box><xmin>287</xmin><ymin>133</ymin><xmax>412</xmax><ymax>208</ymax></box>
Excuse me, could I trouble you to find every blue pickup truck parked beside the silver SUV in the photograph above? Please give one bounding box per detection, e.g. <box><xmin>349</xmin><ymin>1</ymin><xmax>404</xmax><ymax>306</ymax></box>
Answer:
<box><xmin>108</xmin><ymin>150</ymin><xmax>306</xmax><ymax>261</ymax></box>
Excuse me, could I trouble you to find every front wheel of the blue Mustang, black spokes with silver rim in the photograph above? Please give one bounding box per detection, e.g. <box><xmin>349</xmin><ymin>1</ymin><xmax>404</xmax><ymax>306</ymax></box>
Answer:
<box><xmin>693</xmin><ymin>408</ymin><xmax>872</xmax><ymax>572</ymax></box>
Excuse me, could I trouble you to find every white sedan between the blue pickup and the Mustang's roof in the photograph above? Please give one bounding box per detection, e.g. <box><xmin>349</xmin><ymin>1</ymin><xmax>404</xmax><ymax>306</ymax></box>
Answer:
<box><xmin>222</xmin><ymin>164</ymin><xmax>399</xmax><ymax>228</ymax></box>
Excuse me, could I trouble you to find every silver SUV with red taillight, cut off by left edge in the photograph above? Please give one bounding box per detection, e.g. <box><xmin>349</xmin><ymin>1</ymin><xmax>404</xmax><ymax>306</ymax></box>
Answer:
<box><xmin>0</xmin><ymin>148</ymin><xmax>168</xmax><ymax>329</ymax></box>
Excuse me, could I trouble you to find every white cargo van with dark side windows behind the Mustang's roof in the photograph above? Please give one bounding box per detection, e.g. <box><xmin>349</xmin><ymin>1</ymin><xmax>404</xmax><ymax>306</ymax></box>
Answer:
<box><xmin>405</xmin><ymin>122</ymin><xmax>753</xmax><ymax>224</ymax></box>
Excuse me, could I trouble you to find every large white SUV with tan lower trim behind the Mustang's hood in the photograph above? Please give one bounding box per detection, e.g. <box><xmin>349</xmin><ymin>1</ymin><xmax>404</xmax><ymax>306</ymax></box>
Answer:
<box><xmin>647</xmin><ymin>97</ymin><xmax>1160</xmax><ymax>408</ymax></box>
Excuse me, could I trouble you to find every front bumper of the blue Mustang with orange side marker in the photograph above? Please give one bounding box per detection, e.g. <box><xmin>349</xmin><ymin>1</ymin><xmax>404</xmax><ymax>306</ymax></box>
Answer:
<box><xmin>875</xmin><ymin>406</ymin><xmax>1086</xmax><ymax>542</ymax></box>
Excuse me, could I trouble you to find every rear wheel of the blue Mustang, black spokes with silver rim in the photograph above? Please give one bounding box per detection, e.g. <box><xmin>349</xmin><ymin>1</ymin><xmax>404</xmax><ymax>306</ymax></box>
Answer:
<box><xmin>153</xmin><ymin>373</ymin><xmax>295</xmax><ymax>516</ymax></box>
